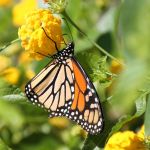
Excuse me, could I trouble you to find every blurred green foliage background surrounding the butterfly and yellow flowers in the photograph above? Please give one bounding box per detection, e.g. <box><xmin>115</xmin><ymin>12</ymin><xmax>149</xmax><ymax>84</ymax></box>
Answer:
<box><xmin>0</xmin><ymin>0</ymin><xmax>150</xmax><ymax>150</ymax></box>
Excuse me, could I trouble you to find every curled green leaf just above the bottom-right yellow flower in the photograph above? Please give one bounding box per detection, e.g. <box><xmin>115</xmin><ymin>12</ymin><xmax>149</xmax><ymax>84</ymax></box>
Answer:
<box><xmin>108</xmin><ymin>95</ymin><xmax>146</xmax><ymax>138</ymax></box>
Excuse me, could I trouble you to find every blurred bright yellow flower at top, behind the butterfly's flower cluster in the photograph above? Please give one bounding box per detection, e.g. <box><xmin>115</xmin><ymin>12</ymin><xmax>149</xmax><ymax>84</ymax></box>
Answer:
<box><xmin>13</xmin><ymin>0</ymin><xmax>37</xmax><ymax>26</ymax></box>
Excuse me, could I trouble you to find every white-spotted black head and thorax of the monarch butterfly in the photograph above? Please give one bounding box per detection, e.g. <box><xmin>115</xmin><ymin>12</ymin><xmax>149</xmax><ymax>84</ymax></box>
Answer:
<box><xmin>52</xmin><ymin>42</ymin><xmax>74</xmax><ymax>62</ymax></box>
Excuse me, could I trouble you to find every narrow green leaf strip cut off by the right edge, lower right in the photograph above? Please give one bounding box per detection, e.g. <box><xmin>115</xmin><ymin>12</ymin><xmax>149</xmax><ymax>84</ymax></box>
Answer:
<box><xmin>144</xmin><ymin>95</ymin><xmax>150</xmax><ymax>137</ymax></box>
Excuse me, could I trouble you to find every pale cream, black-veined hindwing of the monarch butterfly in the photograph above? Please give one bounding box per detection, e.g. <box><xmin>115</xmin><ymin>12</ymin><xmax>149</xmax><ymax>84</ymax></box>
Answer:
<box><xmin>25</xmin><ymin>59</ymin><xmax>74</xmax><ymax>117</ymax></box>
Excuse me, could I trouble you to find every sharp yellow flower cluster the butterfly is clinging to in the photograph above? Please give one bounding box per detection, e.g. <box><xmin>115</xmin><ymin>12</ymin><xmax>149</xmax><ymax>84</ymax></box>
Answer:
<box><xmin>18</xmin><ymin>9</ymin><xmax>63</xmax><ymax>59</ymax></box>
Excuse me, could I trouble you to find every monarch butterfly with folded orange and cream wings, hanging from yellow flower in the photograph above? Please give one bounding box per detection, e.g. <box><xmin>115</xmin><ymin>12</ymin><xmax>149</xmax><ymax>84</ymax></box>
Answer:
<box><xmin>25</xmin><ymin>28</ymin><xmax>104</xmax><ymax>134</ymax></box>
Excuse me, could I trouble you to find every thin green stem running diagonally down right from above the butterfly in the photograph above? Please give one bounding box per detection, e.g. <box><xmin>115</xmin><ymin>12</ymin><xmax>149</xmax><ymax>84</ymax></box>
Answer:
<box><xmin>62</xmin><ymin>11</ymin><xmax>125</xmax><ymax>66</ymax></box>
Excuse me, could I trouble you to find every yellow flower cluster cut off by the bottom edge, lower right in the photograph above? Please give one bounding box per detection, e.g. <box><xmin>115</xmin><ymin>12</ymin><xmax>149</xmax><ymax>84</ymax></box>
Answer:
<box><xmin>104</xmin><ymin>131</ymin><xmax>146</xmax><ymax>150</ymax></box>
